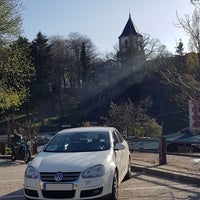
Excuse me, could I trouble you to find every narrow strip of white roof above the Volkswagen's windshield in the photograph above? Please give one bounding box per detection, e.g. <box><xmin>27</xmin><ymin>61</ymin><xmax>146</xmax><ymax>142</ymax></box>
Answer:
<box><xmin>58</xmin><ymin>126</ymin><xmax>114</xmax><ymax>133</ymax></box>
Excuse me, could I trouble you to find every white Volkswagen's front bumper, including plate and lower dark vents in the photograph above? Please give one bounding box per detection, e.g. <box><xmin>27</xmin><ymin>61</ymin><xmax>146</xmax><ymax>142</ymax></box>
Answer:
<box><xmin>24</xmin><ymin>175</ymin><xmax>112</xmax><ymax>200</ymax></box>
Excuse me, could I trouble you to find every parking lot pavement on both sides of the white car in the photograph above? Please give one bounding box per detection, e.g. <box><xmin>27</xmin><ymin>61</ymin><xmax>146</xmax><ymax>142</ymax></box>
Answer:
<box><xmin>0</xmin><ymin>159</ymin><xmax>200</xmax><ymax>200</ymax></box>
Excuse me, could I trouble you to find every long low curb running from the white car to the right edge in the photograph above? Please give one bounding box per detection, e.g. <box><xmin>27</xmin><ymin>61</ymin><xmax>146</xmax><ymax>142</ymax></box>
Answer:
<box><xmin>131</xmin><ymin>164</ymin><xmax>200</xmax><ymax>185</ymax></box>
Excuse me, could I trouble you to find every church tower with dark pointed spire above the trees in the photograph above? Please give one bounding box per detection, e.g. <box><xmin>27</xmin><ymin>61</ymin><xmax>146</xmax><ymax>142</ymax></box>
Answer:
<box><xmin>117</xmin><ymin>14</ymin><xmax>144</xmax><ymax>65</ymax></box>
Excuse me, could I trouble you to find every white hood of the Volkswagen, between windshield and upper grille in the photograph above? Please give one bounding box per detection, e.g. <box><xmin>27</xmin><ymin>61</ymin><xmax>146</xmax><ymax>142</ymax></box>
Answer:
<box><xmin>30</xmin><ymin>150</ymin><xmax>109</xmax><ymax>172</ymax></box>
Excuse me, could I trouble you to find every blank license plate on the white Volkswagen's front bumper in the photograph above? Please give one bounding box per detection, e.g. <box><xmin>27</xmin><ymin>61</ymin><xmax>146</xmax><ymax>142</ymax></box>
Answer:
<box><xmin>43</xmin><ymin>183</ymin><xmax>73</xmax><ymax>191</ymax></box>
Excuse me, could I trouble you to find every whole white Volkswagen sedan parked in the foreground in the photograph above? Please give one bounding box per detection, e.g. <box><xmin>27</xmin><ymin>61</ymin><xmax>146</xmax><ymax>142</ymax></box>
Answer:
<box><xmin>24</xmin><ymin>127</ymin><xmax>131</xmax><ymax>200</ymax></box>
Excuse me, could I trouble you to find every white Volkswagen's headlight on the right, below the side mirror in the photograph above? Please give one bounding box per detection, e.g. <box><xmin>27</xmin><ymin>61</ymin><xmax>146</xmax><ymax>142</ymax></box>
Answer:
<box><xmin>82</xmin><ymin>165</ymin><xmax>105</xmax><ymax>178</ymax></box>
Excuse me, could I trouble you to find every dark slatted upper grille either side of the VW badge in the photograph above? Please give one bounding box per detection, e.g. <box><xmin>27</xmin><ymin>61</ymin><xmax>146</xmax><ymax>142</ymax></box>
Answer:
<box><xmin>40</xmin><ymin>172</ymin><xmax>80</xmax><ymax>182</ymax></box>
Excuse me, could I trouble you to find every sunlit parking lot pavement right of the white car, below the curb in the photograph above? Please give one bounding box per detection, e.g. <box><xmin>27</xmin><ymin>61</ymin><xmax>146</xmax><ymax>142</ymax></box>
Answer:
<box><xmin>119</xmin><ymin>173</ymin><xmax>200</xmax><ymax>200</ymax></box>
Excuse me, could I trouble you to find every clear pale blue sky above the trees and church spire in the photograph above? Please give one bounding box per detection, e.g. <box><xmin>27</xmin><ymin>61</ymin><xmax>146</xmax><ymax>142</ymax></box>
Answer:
<box><xmin>22</xmin><ymin>0</ymin><xmax>194</xmax><ymax>54</ymax></box>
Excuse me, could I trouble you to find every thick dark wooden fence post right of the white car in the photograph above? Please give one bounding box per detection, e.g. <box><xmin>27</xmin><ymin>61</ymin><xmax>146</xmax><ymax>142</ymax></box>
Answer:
<box><xmin>158</xmin><ymin>135</ymin><xmax>167</xmax><ymax>165</ymax></box>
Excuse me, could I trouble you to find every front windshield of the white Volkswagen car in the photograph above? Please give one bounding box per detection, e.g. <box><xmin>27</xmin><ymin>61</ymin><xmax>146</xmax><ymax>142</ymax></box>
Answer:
<box><xmin>44</xmin><ymin>131</ymin><xmax>110</xmax><ymax>152</ymax></box>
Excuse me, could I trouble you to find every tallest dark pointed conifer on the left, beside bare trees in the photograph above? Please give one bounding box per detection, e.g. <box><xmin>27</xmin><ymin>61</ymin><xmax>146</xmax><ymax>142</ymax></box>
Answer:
<box><xmin>31</xmin><ymin>32</ymin><xmax>52</xmax><ymax>122</ymax></box>
